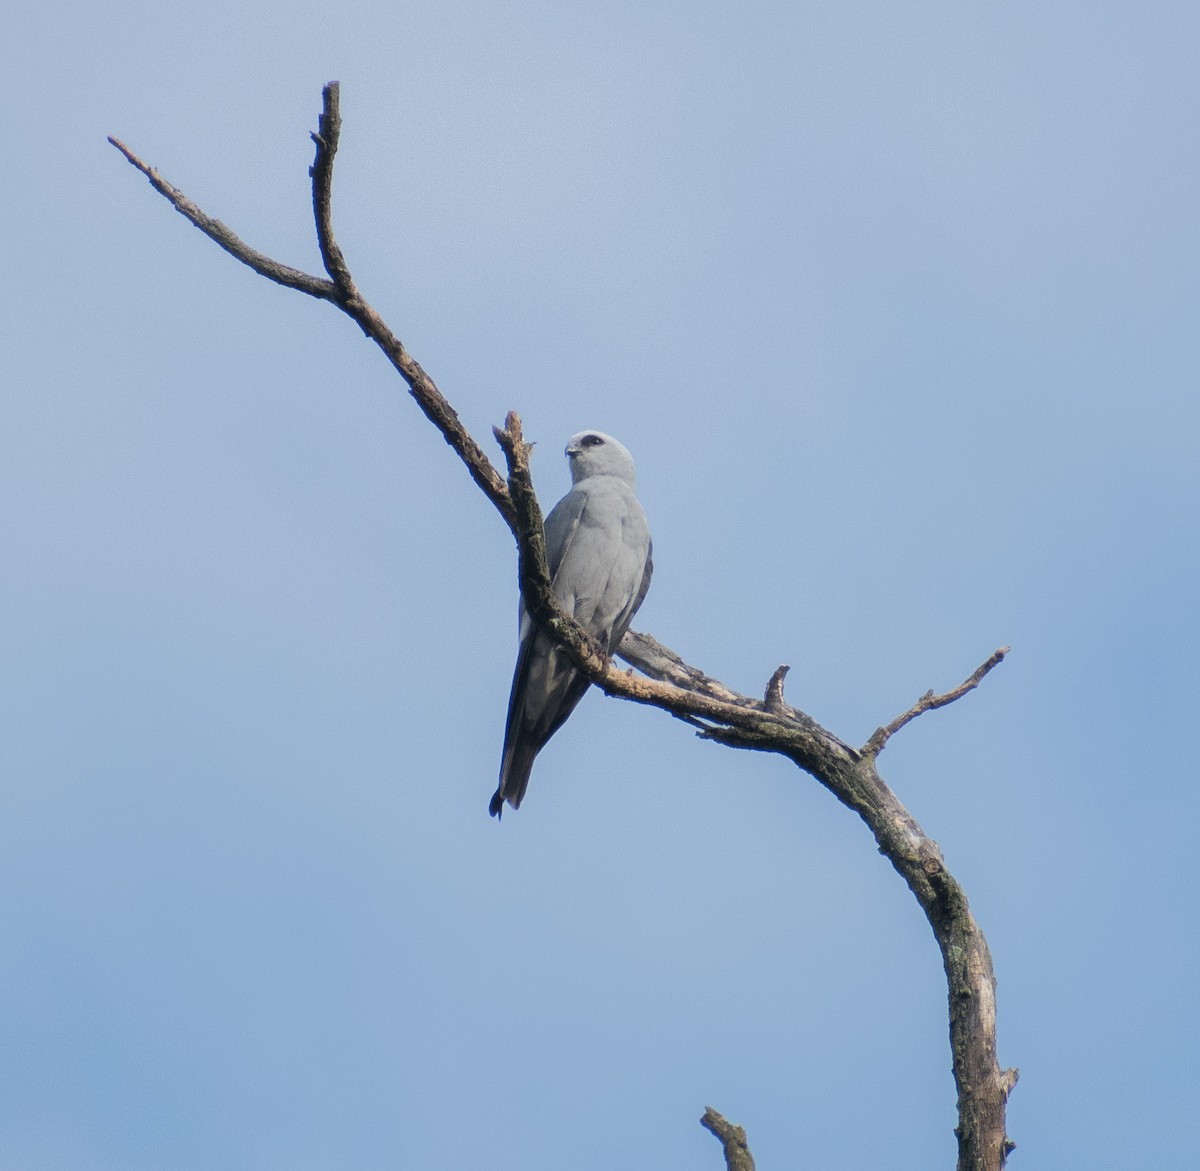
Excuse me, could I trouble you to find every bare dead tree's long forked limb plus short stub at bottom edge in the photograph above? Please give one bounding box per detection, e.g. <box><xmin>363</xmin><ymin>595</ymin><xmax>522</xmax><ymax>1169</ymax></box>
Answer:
<box><xmin>109</xmin><ymin>82</ymin><xmax>1018</xmax><ymax>1171</ymax></box>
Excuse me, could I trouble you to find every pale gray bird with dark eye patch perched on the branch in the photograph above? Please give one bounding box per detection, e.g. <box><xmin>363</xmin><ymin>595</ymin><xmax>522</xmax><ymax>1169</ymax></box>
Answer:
<box><xmin>488</xmin><ymin>431</ymin><xmax>654</xmax><ymax>817</ymax></box>
